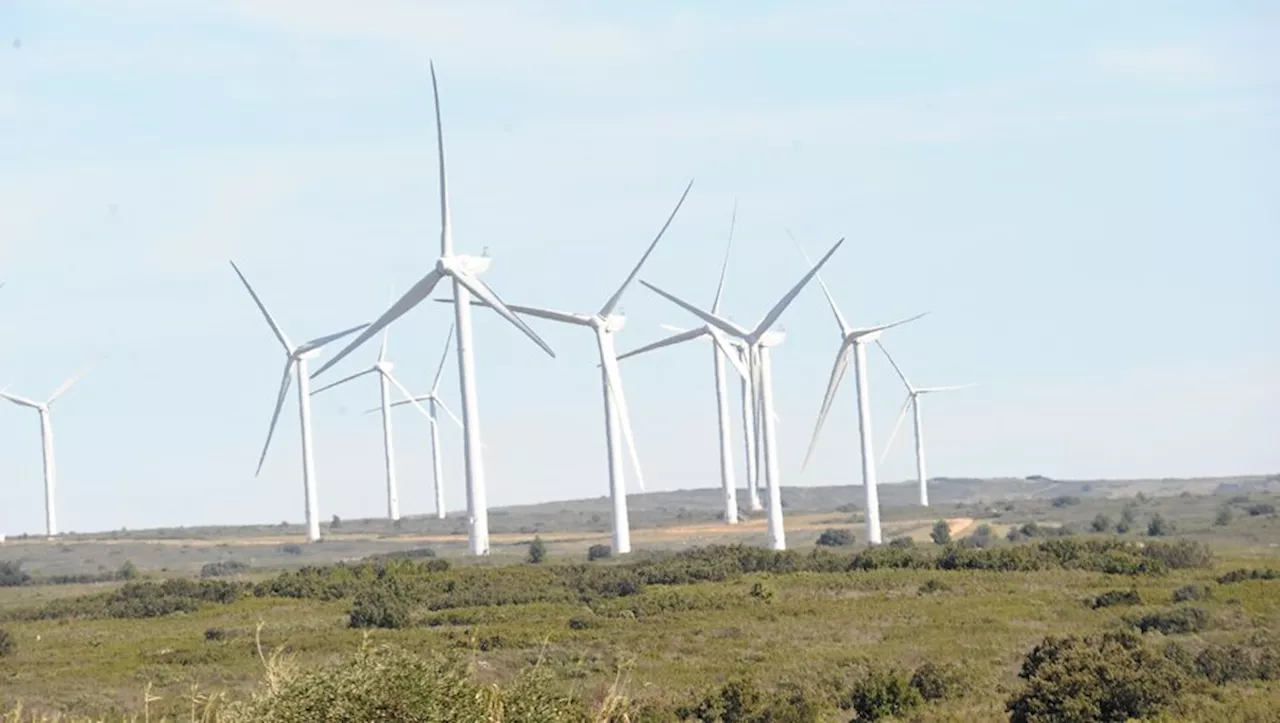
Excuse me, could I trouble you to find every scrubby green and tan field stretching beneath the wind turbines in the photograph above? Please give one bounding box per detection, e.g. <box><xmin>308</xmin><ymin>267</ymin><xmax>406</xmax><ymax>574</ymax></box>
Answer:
<box><xmin>0</xmin><ymin>478</ymin><xmax>1280</xmax><ymax>720</ymax></box>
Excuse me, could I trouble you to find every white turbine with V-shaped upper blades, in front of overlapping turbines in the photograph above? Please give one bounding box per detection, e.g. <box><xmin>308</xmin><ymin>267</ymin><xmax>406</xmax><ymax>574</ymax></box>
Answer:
<box><xmin>640</xmin><ymin>238</ymin><xmax>845</xmax><ymax>550</ymax></box>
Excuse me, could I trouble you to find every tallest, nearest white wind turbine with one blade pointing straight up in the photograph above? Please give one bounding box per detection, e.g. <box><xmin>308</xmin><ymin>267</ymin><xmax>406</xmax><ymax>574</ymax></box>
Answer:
<box><xmin>312</xmin><ymin>63</ymin><xmax>556</xmax><ymax>555</ymax></box>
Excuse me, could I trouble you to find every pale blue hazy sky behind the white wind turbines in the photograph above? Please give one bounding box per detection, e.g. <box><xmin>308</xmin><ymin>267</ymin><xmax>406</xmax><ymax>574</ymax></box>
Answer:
<box><xmin>0</xmin><ymin>0</ymin><xmax>1280</xmax><ymax>535</ymax></box>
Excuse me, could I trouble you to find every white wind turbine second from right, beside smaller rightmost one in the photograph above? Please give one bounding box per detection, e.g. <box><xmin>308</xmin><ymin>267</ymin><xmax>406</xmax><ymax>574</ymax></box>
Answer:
<box><xmin>796</xmin><ymin>235</ymin><xmax>928</xmax><ymax>545</ymax></box>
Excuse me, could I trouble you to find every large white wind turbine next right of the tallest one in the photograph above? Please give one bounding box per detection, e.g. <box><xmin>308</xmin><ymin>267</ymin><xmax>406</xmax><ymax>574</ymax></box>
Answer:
<box><xmin>439</xmin><ymin>180</ymin><xmax>694</xmax><ymax>554</ymax></box>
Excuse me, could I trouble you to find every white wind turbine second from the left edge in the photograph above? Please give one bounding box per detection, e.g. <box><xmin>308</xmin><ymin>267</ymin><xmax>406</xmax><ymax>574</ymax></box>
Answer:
<box><xmin>230</xmin><ymin>261</ymin><xmax>369</xmax><ymax>543</ymax></box>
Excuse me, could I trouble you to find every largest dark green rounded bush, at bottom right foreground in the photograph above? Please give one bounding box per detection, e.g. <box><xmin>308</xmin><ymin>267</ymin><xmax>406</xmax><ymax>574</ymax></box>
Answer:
<box><xmin>1005</xmin><ymin>632</ymin><xmax>1184</xmax><ymax>723</ymax></box>
